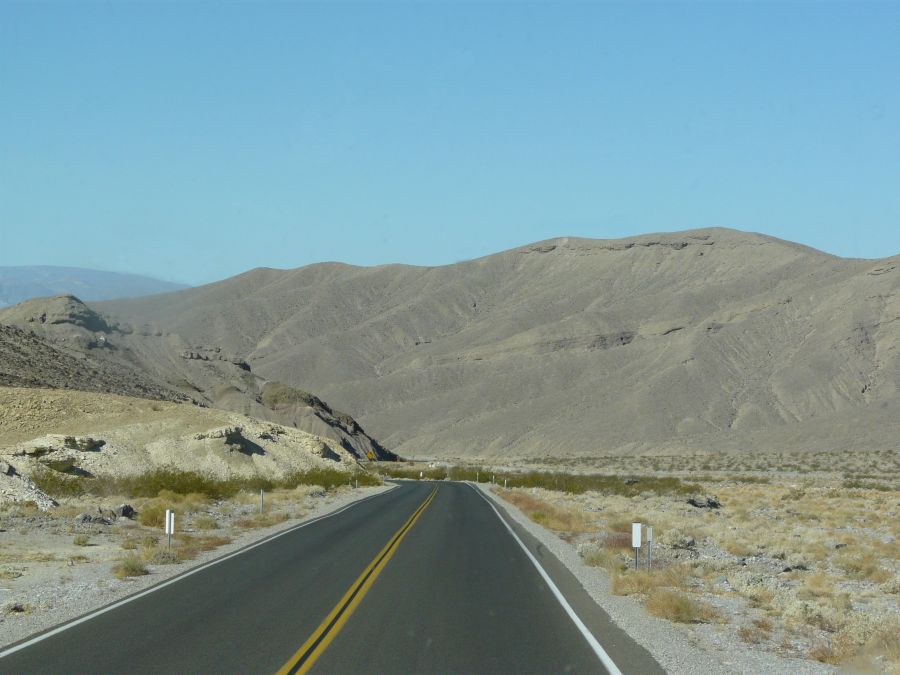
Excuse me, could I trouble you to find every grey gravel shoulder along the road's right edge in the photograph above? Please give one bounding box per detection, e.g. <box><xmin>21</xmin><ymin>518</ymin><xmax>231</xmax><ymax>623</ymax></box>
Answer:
<box><xmin>477</xmin><ymin>484</ymin><xmax>835</xmax><ymax>675</ymax></box>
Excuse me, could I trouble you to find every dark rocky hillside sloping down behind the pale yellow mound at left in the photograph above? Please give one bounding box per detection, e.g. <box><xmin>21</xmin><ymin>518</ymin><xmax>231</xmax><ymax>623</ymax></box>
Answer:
<box><xmin>0</xmin><ymin>295</ymin><xmax>394</xmax><ymax>459</ymax></box>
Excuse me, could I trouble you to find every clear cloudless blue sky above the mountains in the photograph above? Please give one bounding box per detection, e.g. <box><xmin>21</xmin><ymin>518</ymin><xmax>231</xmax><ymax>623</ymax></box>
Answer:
<box><xmin>0</xmin><ymin>0</ymin><xmax>900</xmax><ymax>284</ymax></box>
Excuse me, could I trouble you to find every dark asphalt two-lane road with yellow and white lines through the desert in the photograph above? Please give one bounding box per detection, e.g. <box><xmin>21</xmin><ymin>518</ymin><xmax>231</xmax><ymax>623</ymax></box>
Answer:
<box><xmin>0</xmin><ymin>482</ymin><xmax>662</xmax><ymax>674</ymax></box>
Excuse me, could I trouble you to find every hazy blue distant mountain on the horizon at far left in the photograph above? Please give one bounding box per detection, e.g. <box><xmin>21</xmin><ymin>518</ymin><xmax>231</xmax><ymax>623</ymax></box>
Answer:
<box><xmin>0</xmin><ymin>265</ymin><xmax>187</xmax><ymax>307</ymax></box>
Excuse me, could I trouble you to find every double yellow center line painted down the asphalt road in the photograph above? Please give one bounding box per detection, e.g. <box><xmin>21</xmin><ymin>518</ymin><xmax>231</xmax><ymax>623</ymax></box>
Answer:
<box><xmin>278</xmin><ymin>486</ymin><xmax>438</xmax><ymax>675</ymax></box>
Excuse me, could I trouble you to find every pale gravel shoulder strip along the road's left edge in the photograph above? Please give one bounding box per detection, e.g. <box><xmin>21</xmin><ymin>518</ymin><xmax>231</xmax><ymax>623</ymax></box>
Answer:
<box><xmin>0</xmin><ymin>485</ymin><xmax>393</xmax><ymax>648</ymax></box>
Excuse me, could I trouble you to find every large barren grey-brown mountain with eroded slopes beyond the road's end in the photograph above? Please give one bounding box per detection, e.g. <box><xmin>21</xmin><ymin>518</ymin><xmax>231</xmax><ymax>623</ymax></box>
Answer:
<box><xmin>15</xmin><ymin>229</ymin><xmax>900</xmax><ymax>456</ymax></box>
